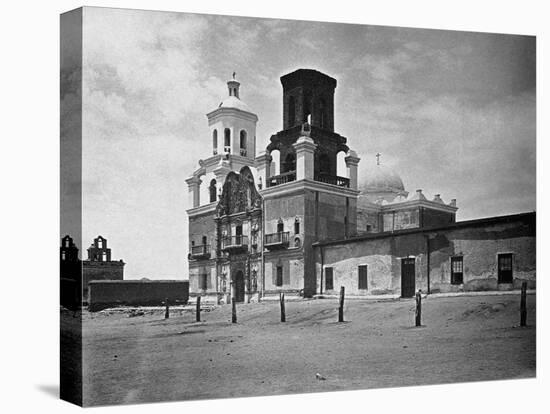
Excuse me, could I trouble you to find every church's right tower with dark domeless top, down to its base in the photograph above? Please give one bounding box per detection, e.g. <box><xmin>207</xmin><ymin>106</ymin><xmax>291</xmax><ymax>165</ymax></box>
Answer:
<box><xmin>256</xmin><ymin>69</ymin><xmax>359</xmax><ymax>297</ymax></box>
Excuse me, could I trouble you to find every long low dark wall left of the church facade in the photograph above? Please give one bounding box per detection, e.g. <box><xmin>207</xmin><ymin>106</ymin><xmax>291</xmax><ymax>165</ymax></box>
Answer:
<box><xmin>88</xmin><ymin>280</ymin><xmax>189</xmax><ymax>312</ymax></box>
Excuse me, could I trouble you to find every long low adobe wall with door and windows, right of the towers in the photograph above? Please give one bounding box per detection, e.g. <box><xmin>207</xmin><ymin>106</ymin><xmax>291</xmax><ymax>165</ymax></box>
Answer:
<box><xmin>316</xmin><ymin>214</ymin><xmax>536</xmax><ymax>295</ymax></box>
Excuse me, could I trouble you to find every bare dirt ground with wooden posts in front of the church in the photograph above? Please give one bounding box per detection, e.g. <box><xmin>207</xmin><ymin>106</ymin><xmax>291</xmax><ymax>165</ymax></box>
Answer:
<box><xmin>78</xmin><ymin>295</ymin><xmax>536</xmax><ymax>405</ymax></box>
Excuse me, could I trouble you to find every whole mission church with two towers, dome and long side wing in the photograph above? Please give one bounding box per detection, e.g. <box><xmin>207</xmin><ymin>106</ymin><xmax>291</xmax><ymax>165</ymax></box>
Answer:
<box><xmin>186</xmin><ymin>69</ymin><xmax>536</xmax><ymax>303</ymax></box>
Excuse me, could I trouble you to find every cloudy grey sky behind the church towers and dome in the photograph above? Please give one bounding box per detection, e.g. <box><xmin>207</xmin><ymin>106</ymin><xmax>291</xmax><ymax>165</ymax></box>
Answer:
<box><xmin>62</xmin><ymin>8</ymin><xmax>536</xmax><ymax>279</ymax></box>
